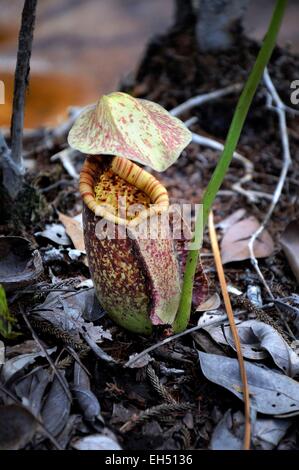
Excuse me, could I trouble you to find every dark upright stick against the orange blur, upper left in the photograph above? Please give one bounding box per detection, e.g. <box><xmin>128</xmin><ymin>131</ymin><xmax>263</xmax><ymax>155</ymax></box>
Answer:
<box><xmin>11</xmin><ymin>0</ymin><xmax>37</xmax><ymax>178</ymax></box>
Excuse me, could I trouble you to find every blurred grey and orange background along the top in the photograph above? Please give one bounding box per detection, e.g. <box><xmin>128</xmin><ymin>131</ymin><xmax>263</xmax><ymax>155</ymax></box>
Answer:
<box><xmin>0</xmin><ymin>0</ymin><xmax>299</xmax><ymax>127</ymax></box>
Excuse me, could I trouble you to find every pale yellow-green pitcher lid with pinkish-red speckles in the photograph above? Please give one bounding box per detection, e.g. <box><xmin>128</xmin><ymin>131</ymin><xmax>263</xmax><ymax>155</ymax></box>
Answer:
<box><xmin>68</xmin><ymin>92</ymin><xmax>192</xmax><ymax>171</ymax></box>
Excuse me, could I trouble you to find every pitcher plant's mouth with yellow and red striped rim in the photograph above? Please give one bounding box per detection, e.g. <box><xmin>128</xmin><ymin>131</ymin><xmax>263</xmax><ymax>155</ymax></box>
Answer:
<box><xmin>79</xmin><ymin>155</ymin><xmax>169</xmax><ymax>227</ymax></box>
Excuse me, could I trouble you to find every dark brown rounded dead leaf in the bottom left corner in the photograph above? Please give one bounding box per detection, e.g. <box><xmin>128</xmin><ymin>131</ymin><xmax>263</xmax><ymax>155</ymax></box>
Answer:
<box><xmin>0</xmin><ymin>405</ymin><xmax>37</xmax><ymax>450</ymax></box>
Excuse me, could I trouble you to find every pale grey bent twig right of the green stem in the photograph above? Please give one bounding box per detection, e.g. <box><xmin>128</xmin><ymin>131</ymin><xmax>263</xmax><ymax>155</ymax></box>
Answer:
<box><xmin>248</xmin><ymin>69</ymin><xmax>292</xmax><ymax>299</ymax></box>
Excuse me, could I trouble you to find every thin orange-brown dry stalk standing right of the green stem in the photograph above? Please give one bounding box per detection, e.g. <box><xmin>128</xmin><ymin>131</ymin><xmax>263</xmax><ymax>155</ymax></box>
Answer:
<box><xmin>209</xmin><ymin>211</ymin><xmax>251</xmax><ymax>450</ymax></box>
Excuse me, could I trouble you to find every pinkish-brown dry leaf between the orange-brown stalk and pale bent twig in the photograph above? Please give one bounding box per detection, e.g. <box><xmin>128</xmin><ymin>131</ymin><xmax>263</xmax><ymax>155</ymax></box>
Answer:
<box><xmin>221</xmin><ymin>216</ymin><xmax>274</xmax><ymax>264</ymax></box>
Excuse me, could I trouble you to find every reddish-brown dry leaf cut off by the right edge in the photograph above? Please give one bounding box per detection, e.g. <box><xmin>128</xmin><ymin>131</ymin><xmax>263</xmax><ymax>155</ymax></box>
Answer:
<box><xmin>280</xmin><ymin>220</ymin><xmax>299</xmax><ymax>282</ymax></box>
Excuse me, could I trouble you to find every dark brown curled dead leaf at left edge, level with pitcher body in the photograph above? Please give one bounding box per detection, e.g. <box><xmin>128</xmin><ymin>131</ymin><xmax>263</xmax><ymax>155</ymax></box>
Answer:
<box><xmin>0</xmin><ymin>237</ymin><xmax>43</xmax><ymax>292</ymax></box>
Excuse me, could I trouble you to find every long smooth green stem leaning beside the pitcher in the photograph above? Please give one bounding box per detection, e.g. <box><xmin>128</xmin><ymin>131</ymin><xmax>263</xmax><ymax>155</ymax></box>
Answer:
<box><xmin>173</xmin><ymin>0</ymin><xmax>287</xmax><ymax>333</ymax></box>
